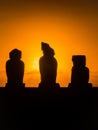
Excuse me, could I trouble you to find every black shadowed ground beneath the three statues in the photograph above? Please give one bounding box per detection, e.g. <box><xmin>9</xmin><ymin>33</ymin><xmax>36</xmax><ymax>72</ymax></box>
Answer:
<box><xmin>0</xmin><ymin>88</ymin><xmax>98</xmax><ymax>130</ymax></box>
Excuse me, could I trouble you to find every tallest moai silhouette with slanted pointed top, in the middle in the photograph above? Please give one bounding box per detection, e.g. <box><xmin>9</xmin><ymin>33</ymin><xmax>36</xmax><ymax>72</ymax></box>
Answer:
<box><xmin>39</xmin><ymin>42</ymin><xmax>59</xmax><ymax>88</ymax></box>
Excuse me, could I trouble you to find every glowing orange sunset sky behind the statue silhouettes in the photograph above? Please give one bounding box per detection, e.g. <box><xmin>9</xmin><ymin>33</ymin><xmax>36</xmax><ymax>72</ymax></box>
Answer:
<box><xmin>0</xmin><ymin>0</ymin><xmax>98</xmax><ymax>86</ymax></box>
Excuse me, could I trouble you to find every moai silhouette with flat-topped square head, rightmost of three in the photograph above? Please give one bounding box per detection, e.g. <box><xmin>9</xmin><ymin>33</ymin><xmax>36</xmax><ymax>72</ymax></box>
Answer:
<box><xmin>69</xmin><ymin>55</ymin><xmax>92</xmax><ymax>88</ymax></box>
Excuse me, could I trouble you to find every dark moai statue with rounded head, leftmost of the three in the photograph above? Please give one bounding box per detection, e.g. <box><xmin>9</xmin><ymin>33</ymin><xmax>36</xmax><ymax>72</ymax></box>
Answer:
<box><xmin>6</xmin><ymin>49</ymin><xmax>25</xmax><ymax>88</ymax></box>
